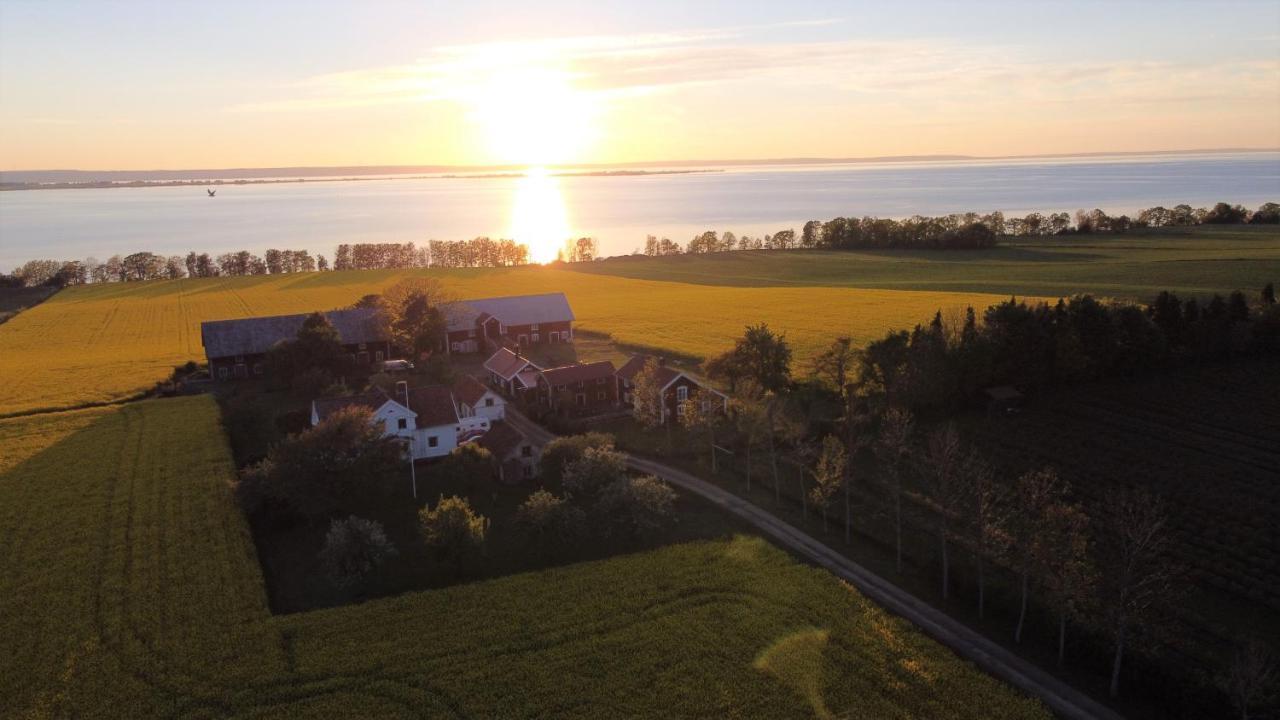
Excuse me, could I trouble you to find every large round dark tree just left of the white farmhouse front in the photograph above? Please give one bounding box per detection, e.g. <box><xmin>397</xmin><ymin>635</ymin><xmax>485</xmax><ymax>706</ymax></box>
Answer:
<box><xmin>241</xmin><ymin>407</ymin><xmax>404</xmax><ymax>520</ymax></box>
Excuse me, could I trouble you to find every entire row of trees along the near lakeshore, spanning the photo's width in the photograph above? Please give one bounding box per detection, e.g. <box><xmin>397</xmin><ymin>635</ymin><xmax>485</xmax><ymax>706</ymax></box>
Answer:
<box><xmin>0</xmin><ymin>197</ymin><xmax>1280</xmax><ymax>288</ymax></box>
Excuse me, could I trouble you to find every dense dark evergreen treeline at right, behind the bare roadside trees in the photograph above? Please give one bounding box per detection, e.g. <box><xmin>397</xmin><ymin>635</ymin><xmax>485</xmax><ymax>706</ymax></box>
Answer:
<box><xmin>856</xmin><ymin>284</ymin><xmax>1280</xmax><ymax>410</ymax></box>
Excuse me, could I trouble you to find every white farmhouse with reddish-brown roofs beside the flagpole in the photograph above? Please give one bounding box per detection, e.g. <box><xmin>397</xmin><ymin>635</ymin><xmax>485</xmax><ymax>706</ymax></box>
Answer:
<box><xmin>311</xmin><ymin>382</ymin><xmax>490</xmax><ymax>460</ymax></box>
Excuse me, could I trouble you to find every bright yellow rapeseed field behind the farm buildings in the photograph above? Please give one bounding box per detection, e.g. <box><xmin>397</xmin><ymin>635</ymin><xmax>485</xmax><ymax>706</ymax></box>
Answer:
<box><xmin>0</xmin><ymin>266</ymin><xmax>1024</xmax><ymax>416</ymax></box>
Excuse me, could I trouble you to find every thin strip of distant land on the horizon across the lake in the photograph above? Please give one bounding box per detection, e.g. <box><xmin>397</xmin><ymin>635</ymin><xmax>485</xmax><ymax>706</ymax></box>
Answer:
<box><xmin>0</xmin><ymin>147</ymin><xmax>1280</xmax><ymax>191</ymax></box>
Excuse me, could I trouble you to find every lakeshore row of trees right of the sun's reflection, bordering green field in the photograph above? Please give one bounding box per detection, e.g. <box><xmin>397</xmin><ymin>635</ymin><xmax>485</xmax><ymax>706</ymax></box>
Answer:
<box><xmin>643</xmin><ymin>202</ymin><xmax>1280</xmax><ymax>256</ymax></box>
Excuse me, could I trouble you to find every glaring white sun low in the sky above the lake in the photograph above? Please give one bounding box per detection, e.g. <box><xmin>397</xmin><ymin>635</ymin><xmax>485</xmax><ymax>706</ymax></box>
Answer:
<box><xmin>467</xmin><ymin>67</ymin><xmax>598</xmax><ymax>167</ymax></box>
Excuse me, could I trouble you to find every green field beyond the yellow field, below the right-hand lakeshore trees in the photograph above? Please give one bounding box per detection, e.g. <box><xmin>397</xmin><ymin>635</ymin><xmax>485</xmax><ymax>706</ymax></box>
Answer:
<box><xmin>584</xmin><ymin>225</ymin><xmax>1280</xmax><ymax>301</ymax></box>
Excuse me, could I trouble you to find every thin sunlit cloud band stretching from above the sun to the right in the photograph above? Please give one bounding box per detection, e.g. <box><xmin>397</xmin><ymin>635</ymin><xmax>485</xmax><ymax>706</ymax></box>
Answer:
<box><xmin>233</xmin><ymin>20</ymin><xmax>1280</xmax><ymax>111</ymax></box>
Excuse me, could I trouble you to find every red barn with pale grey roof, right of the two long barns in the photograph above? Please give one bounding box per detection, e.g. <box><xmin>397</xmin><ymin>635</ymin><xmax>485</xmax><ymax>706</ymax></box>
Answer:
<box><xmin>444</xmin><ymin>292</ymin><xmax>573</xmax><ymax>352</ymax></box>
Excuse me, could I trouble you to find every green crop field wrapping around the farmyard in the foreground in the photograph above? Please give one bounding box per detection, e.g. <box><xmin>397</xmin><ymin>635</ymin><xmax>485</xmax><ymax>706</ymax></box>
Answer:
<box><xmin>0</xmin><ymin>397</ymin><xmax>1048</xmax><ymax>717</ymax></box>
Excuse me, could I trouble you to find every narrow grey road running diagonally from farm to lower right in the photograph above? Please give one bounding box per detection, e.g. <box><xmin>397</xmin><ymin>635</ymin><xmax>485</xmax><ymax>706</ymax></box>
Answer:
<box><xmin>507</xmin><ymin>405</ymin><xmax>1121</xmax><ymax>720</ymax></box>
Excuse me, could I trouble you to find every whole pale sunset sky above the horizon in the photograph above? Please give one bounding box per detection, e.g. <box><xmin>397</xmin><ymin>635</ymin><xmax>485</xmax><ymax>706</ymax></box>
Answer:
<box><xmin>0</xmin><ymin>0</ymin><xmax>1280</xmax><ymax>170</ymax></box>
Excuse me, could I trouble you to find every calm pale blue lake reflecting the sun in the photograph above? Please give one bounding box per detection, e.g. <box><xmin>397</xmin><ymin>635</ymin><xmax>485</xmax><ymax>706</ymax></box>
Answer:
<box><xmin>0</xmin><ymin>152</ymin><xmax>1280</xmax><ymax>269</ymax></box>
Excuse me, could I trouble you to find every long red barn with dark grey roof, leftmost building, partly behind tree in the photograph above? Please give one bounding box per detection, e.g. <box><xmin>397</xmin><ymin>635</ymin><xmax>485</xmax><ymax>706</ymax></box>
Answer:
<box><xmin>200</xmin><ymin>307</ymin><xmax>390</xmax><ymax>380</ymax></box>
